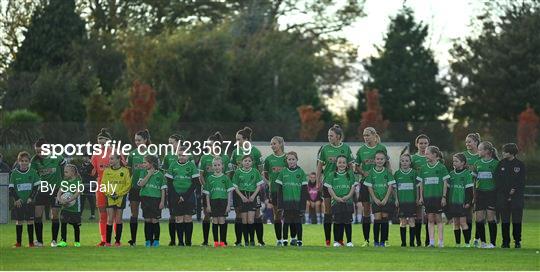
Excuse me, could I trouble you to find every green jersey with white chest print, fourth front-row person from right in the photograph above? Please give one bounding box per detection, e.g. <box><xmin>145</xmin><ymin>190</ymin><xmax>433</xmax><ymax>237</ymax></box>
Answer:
<box><xmin>416</xmin><ymin>162</ymin><xmax>450</xmax><ymax>198</ymax></box>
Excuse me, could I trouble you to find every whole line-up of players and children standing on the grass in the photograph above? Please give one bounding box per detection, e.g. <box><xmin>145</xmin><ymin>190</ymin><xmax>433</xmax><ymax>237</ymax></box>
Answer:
<box><xmin>9</xmin><ymin>125</ymin><xmax>525</xmax><ymax>248</ymax></box>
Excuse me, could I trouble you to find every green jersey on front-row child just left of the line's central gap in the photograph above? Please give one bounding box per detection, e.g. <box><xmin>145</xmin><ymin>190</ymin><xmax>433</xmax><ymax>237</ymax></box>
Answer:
<box><xmin>275</xmin><ymin>167</ymin><xmax>307</xmax><ymax>204</ymax></box>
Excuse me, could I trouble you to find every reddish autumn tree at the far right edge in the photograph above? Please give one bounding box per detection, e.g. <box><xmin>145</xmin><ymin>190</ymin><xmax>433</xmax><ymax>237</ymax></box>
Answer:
<box><xmin>517</xmin><ymin>105</ymin><xmax>540</xmax><ymax>152</ymax></box>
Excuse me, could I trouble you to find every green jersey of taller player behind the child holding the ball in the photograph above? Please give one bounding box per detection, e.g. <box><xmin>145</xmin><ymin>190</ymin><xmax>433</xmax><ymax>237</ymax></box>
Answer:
<box><xmin>30</xmin><ymin>156</ymin><xmax>66</xmax><ymax>188</ymax></box>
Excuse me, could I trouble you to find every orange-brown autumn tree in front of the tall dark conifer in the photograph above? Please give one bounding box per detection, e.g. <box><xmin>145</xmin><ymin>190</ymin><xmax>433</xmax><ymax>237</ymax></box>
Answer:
<box><xmin>358</xmin><ymin>89</ymin><xmax>388</xmax><ymax>139</ymax></box>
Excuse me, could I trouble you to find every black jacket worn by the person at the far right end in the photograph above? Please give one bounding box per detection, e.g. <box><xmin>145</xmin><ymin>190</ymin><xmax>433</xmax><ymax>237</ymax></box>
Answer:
<box><xmin>495</xmin><ymin>158</ymin><xmax>526</xmax><ymax>199</ymax></box>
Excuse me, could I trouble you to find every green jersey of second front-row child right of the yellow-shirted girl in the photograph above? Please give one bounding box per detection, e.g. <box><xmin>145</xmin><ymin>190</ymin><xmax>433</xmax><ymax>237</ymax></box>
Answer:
<box><xmin>165</xmin><ymin>160</ymin><xmax>199</xmax><ymax>194</ymax></box>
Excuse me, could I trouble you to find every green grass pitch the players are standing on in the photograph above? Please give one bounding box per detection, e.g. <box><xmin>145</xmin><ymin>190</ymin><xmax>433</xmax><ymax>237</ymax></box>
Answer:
<box><xmin>0</xmin><ymin>210</ymin><xmax>540</xmax><ymax>270</ymax></box>
